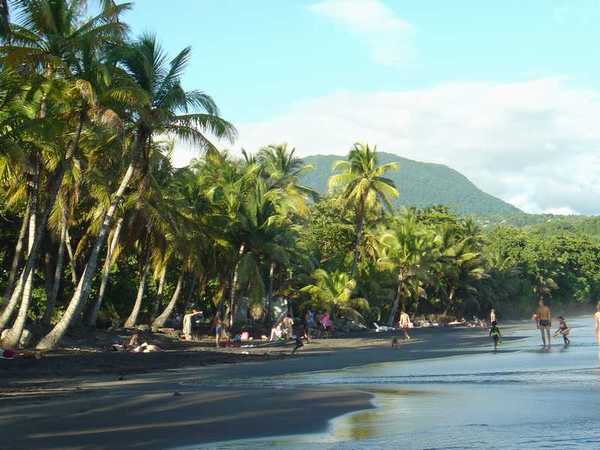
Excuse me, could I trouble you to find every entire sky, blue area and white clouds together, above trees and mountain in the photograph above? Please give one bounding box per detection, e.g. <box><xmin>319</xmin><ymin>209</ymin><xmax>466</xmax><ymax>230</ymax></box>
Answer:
<box><xmin>127</xmin><ymin>0</ymin><xmax>600</xmax><ymax>213</ymax></box>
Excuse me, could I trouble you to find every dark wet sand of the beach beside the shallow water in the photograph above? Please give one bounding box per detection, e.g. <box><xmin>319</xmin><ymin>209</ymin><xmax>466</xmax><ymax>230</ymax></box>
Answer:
<box><xmin>0</xmin><ymin>329</ymin><xmax>516</xmax><ymax>449</ymax></box>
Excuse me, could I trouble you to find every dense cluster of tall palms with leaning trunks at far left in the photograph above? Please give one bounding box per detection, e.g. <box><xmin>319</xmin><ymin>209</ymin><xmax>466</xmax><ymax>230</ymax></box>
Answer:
<box><xmin>0</xmin><ymin>0</ymin><xmax>235</xmax><ymax>349</ymax></box>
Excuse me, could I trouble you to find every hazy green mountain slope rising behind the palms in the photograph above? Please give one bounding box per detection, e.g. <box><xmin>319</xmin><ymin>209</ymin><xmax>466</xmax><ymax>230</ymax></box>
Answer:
<box><xmin>301</xmin><ymin>152</ymin><xmax>525</xmax><ymax>217</ymax></box>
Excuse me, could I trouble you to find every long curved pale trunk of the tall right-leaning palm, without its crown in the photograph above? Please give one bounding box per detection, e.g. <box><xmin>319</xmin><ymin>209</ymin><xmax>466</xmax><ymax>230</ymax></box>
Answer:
<box><xmin>36</xmin><ymin>161</ymin><xmax>135</xmax><ymax>350</ymax></box>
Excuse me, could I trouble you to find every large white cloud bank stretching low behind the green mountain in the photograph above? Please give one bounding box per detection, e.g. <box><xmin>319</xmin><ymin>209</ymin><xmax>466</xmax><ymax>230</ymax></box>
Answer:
<box><xmin>221</xmin><ymin>78</ymin><xmax>600</xmax><ymax>214</ymax></box>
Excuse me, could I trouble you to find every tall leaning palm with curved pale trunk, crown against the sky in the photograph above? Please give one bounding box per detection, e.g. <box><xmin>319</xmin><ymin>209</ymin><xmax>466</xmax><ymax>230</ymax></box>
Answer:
<box><xmin>37</xmin><ymin>35</ymin><xmax>235</xmax><ymax>349</ymax></box>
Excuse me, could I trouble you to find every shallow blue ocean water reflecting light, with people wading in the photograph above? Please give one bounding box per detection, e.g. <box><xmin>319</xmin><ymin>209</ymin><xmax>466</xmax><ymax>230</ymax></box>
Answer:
<box><xmin>189</xmin><ymin>318</ymin><xmax>600</xmax><ymax>450</ymax></box>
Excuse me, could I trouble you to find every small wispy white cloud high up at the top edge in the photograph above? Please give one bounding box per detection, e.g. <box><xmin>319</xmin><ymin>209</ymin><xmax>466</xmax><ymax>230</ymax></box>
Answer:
<box><xmin>309</xmin><ymin>0</ymin><xmax>414</xmax><ymax>66</ymax></box>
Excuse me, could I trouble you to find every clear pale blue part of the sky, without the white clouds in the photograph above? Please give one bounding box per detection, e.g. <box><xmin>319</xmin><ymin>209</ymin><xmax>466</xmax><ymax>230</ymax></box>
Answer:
<box><xmin>128</xmin><ymin>0</ymin><xmax>600</xmax><ymax>121</ymax></box>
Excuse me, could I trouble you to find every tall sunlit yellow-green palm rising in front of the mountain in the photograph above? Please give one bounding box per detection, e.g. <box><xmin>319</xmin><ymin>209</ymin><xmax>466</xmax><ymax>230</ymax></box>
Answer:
<box><xmin>329</xmin><ymin>143</ymin><xmax>398</xmax><ymax>276</ymax></box>
